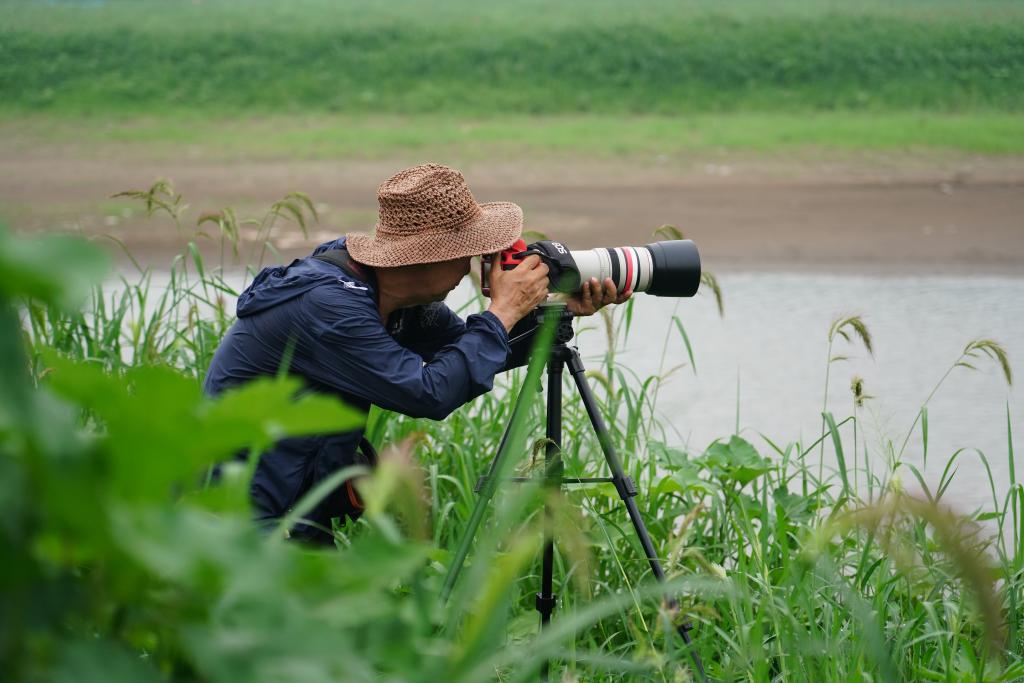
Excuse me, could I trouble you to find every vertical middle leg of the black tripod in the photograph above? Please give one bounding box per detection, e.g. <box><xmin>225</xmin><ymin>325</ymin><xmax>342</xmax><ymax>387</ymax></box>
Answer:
<box><xmin>537</xmin><ymin>357</ymin><xmax>564</xmax><ymax>681</ymax></box>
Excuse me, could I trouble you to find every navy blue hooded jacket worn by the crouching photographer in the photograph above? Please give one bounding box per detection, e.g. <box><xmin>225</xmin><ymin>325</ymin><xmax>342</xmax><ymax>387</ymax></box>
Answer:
<box><xmin>204</xmin><ymin>239</ymin><xmax>530</xmax><ymax>541</ymax></box>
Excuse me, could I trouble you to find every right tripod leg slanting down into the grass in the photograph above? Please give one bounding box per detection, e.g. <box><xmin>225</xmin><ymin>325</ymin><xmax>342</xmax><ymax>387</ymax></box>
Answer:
<box><xmin>565</xmin><ymin>347</ymin><xmax>708</xmax><ymax>680</ymax></box>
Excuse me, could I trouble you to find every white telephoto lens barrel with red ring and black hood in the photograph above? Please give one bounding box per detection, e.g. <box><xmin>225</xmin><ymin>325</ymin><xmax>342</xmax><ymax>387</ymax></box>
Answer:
<box><xmin>561</xmin><ymin>240</ymin><xmax>700</xmax><ymax>297</ymax></box>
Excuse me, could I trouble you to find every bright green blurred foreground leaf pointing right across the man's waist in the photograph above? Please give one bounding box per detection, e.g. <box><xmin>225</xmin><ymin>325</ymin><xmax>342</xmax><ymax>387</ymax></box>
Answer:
<box><xmin>46</xmin><ymin>354</ymin><xmax>362</xmax><ymax>499</ymax></box>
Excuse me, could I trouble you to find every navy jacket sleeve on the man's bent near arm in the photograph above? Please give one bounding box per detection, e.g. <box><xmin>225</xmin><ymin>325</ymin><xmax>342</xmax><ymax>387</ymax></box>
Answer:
<box><xmin>294</xmin><ymin>287</ymin><xmax>509</xmax><ymax>420</ymax></box>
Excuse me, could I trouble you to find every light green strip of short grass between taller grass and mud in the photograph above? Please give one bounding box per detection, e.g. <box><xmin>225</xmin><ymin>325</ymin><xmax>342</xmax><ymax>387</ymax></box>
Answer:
<box><xmin>8</xmin><ymin>112</ymin><xmax>1024</xmax><ymax>161</ymax></box>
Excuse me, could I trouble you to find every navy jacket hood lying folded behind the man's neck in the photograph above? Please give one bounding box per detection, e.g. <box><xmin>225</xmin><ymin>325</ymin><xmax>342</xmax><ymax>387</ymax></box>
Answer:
<box><xmin>236</xmin><ymin>238</ymin><xmax>373</xmax><ymax>317</ymax></box>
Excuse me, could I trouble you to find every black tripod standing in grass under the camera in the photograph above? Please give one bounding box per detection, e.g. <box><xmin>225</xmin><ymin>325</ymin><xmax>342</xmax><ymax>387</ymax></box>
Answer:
<box><xmin>443</xmin><ymin>305</ymin><xmax>707</xmax><ymax>681</ymax></box>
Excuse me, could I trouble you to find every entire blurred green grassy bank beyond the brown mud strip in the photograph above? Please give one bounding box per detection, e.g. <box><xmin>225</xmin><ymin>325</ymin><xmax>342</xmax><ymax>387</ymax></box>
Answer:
<box><xmin>0</xmin><ymin>1</ymin><xmax>1024</xmax><ymax>157</ymax></box>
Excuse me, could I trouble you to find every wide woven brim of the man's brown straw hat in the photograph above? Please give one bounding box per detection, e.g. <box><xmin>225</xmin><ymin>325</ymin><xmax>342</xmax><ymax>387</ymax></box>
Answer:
<box><xmin>345</xmin><ymin>202</ymin><xmax>522</xmax><ymax>268</ymax></box>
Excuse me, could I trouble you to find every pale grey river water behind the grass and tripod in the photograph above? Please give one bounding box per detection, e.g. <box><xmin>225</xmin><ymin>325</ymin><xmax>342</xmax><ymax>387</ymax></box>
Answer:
<box><xmin>132</xmin><ymin>271</ymin><xmax>1024</xmax><ymax>524</ymax></box>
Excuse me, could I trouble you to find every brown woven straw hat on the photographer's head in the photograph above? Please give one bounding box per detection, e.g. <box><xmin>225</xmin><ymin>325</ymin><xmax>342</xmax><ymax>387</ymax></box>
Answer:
<box><xmin>346</xmin><ymin>164</ymin><xmax>522</xmax><ymax>267</ymax></box>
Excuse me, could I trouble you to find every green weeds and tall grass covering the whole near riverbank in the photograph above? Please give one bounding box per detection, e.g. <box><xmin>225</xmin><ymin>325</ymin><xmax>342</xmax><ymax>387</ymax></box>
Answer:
<box><xmin>0</xmin><ymin>184</ymin><xmax>1024</xmax><ymax>681</ymax></box>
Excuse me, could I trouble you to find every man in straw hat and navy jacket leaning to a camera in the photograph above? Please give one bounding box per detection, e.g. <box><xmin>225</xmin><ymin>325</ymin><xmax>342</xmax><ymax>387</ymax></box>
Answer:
<box><xmin>204</xmin><ymin>164</ymin><xmax>629</xmax><ymax>543</ymax></box>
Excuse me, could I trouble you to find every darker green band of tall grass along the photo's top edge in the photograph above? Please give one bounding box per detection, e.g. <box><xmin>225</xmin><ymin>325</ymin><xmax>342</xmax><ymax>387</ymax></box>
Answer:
<box><xmin>0</xmin><ymin>0</ymin><xmax>1024</xmax><ymax>117</ymax></box>
